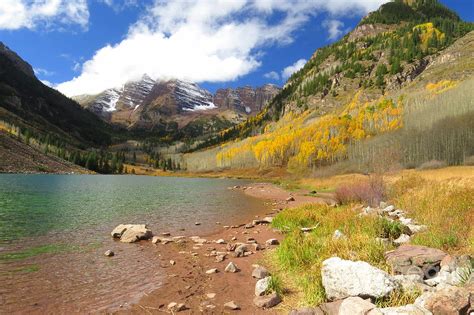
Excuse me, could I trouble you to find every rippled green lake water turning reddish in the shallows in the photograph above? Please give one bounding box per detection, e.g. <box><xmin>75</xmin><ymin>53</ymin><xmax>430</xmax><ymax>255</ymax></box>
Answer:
<box><xmin>0</xmin><ymin>174</ymin><xmax>264</xmax><ymax>313</ymax></box>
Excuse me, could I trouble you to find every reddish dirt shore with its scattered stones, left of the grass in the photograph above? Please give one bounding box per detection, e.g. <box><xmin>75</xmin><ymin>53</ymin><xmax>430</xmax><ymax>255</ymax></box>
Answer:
<box><xmin>105</xmin><ymin>183</ymin><xmax>334</xmax><ymax>314</ymax></box>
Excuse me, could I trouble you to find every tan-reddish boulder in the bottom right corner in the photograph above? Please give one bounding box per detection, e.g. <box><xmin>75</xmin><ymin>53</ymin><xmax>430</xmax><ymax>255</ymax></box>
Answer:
<box><xmin>415</xmin><ymin>286</ymin><xmax>470</xmax><ymax>314</ymax></box>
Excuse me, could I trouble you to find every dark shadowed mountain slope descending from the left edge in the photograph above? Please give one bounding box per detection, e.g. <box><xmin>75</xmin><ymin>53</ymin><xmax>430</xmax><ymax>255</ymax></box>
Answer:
<box><xmin>0</xmin><ymin>43</ymin><xmax>111</xmax><ymax>146</ymax></box>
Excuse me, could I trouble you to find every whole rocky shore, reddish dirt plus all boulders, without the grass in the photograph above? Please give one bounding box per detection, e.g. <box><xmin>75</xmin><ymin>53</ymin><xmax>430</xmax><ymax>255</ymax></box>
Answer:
<box><xmin>106</xmin><ymin>184</ymin><xmax>474</xmax><ymax>315</ymax></box>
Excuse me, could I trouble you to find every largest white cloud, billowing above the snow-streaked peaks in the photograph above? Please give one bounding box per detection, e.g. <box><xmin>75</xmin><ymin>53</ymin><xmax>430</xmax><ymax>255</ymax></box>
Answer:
<box><xmin>58</xmin><ymin>0</ymin><xmax>387</xmax><ymax>96</ymax></box>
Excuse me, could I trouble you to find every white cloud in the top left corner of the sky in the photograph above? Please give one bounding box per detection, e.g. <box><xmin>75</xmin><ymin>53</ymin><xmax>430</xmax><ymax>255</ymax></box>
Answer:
<box><xmin>0</xmin><ymin>0</ymin><xmax>89</xmax><ymax>30</ymax></box>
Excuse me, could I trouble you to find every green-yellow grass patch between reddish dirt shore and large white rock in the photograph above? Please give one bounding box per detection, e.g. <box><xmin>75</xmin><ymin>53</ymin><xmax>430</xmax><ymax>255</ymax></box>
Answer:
<box><xmin>268</xmin><ymin>205</ymin><xmax>396</xmax><ymax>306</ymax></box>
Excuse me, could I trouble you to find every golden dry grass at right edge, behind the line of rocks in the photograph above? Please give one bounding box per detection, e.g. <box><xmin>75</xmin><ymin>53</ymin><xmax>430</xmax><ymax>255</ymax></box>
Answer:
<box><xmin>391</xmin><ymin>175</ymin><xmax>474</xmax><ymax>254</ymax></box>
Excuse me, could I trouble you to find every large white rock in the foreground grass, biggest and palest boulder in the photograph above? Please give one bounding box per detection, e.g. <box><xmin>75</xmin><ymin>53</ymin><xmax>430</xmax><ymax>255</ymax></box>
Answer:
<box><xmin>321</xmin><ymin>257</ymin><xmax>398</xmax><ymax>300</ymax></box>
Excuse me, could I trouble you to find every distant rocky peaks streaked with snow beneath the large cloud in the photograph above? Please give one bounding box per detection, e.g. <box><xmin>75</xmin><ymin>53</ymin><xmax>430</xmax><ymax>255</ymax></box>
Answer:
<box><xmin>74</xmin><ymin>75</ymin><xmax>280</xmax><ymax>136</ymax></box>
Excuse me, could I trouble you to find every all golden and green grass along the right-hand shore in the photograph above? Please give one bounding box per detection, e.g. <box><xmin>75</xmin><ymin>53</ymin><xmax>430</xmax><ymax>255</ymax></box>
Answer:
<box><xmin>266</xmin><ymin>166</ymin><xmax>474</xmax><ymax>309</ymax></box>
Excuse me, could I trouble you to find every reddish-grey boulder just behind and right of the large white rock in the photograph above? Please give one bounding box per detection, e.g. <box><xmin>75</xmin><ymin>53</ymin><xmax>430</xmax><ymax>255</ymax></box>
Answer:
<box><xmin>385</xmin><ymin>244</ymin><xmax>446</xmax><ymax>279</ymax></box>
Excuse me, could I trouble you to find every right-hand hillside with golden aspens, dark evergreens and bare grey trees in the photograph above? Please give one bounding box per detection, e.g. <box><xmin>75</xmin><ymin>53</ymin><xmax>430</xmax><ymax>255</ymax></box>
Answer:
<box><xmin>185</xmin><ymin>0</ymin><xmax>474</xmax><ymax>172</ymax></box>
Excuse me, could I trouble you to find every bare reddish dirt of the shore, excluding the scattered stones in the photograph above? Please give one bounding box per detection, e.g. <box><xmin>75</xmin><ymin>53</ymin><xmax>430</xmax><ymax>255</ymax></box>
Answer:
<box><xmin>114</xmin><ymin>183</ymin><xmax>331</xmax><ymax>314</ymax></box>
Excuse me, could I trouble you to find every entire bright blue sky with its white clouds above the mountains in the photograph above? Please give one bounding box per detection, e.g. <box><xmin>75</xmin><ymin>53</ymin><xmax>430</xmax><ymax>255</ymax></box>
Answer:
<box><xmin>0</xmin><ymin>0</ymin><xmax>474</xmax><ymax>95</ymax></box>
